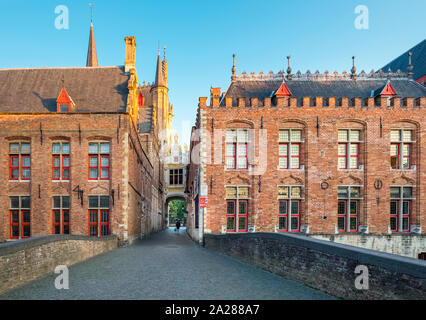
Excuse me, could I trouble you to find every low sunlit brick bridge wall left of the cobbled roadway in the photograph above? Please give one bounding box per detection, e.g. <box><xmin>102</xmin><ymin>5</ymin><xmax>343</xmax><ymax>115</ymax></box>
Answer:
<box><xmin>0</xmin><ymin>235</ymin><xmax>118</xmax><ymax>294</ymax></box>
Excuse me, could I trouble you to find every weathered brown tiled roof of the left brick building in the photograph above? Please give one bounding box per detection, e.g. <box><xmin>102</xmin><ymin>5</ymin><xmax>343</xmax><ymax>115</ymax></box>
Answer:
<box><xmin>0</xmin><ymin>66</ymin><xmax>130</xmax><ymax>113</ymax></box>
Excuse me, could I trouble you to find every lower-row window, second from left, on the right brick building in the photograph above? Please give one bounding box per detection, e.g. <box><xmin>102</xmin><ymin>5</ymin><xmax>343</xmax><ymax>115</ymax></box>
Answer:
<box><xmin>278</xmin><ymin>186</ymin><xmax>302</xmax><ymax>232</ymax></box>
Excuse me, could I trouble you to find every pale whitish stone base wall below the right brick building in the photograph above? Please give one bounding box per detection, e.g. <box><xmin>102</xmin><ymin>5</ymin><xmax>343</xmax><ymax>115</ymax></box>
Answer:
<box><xmin>312</xmin><ymin>233</ymin><xmax>426</xmax><ymax>259</ymax></box>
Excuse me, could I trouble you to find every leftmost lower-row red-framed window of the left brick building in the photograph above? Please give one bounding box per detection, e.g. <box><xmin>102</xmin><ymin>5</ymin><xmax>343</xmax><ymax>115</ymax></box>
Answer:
<box><xmin>9</xmin><ymin>196</ymin><xmax>31</xmax><ymax>239</ymax></box>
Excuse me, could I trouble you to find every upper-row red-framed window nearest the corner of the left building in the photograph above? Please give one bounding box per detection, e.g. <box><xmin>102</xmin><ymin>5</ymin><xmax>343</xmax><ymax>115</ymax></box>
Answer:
<box><xmin>89</xmin><ymin>142</ymin><xmax>111</xmax><ymax>180</ymax></box>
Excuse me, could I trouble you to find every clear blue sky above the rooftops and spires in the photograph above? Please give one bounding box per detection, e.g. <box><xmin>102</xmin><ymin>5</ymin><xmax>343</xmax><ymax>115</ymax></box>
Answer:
<box><xmin>0</xmin><ymin>0</ymin><xmax>426</xmax><ymax>143</ymax></box>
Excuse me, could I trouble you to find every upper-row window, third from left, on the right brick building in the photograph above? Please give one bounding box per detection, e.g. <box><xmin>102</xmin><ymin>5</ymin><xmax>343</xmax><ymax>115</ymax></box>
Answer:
<box><xmin>338</xmin><ymin>129</ymin><xmax>361</xmax><ymax>169</ymax></box>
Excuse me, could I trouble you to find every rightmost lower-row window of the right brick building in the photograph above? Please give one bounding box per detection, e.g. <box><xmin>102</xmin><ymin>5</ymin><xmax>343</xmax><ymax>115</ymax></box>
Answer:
<box><xmin>390</xmin><ymin>186</ymin><xmax>414</xmax><ymax>232</ymax></box>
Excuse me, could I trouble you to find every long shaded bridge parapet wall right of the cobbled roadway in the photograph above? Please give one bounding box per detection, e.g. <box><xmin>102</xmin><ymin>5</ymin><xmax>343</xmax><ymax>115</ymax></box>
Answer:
<box><xmin>205</xmin><ymin>233</ymin><xmax>426</xmax><ymax>299</ymax></box>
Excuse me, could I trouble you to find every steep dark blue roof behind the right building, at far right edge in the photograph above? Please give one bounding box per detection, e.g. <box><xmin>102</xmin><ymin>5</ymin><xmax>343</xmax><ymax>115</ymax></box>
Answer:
<box><xmin>382</xmin><ymin>39</ymin><xmax>426</xmax><ymax>80</ymax></box>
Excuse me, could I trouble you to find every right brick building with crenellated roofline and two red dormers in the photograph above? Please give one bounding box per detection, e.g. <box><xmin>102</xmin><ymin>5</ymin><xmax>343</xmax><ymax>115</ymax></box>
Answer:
<box><xmin>188</xmin><ymin>53</ymin><xmax>426</xmax><ymax>251</ymax></box>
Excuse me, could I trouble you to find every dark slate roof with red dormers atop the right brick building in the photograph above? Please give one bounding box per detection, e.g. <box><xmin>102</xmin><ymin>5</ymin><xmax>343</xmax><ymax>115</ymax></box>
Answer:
<box><xmin>222</xmin><ymin>76</ymin><xmax>426</xmax><ymax>106</ymax></box>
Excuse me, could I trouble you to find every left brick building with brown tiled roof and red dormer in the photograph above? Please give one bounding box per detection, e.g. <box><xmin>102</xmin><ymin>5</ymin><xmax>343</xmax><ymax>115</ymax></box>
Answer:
<box><xmin>0</xmin><ymin>24</ymin><xmax>164</xmax><ymax>243</ymax></box>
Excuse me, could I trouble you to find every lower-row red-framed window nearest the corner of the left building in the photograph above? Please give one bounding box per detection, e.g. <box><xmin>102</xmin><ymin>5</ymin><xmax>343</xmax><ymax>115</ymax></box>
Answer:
<box><xmin>88</xmin><ymin>196</ymin><xmax>110</xmax><ymax>237</ymax></box>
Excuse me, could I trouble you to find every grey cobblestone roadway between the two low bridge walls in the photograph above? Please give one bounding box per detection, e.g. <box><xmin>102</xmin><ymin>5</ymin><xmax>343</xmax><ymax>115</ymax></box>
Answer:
<box><xmin>0</xmin><ymin>229</ymin><xmax>333</xmax><ymax>300</ymax></box>
